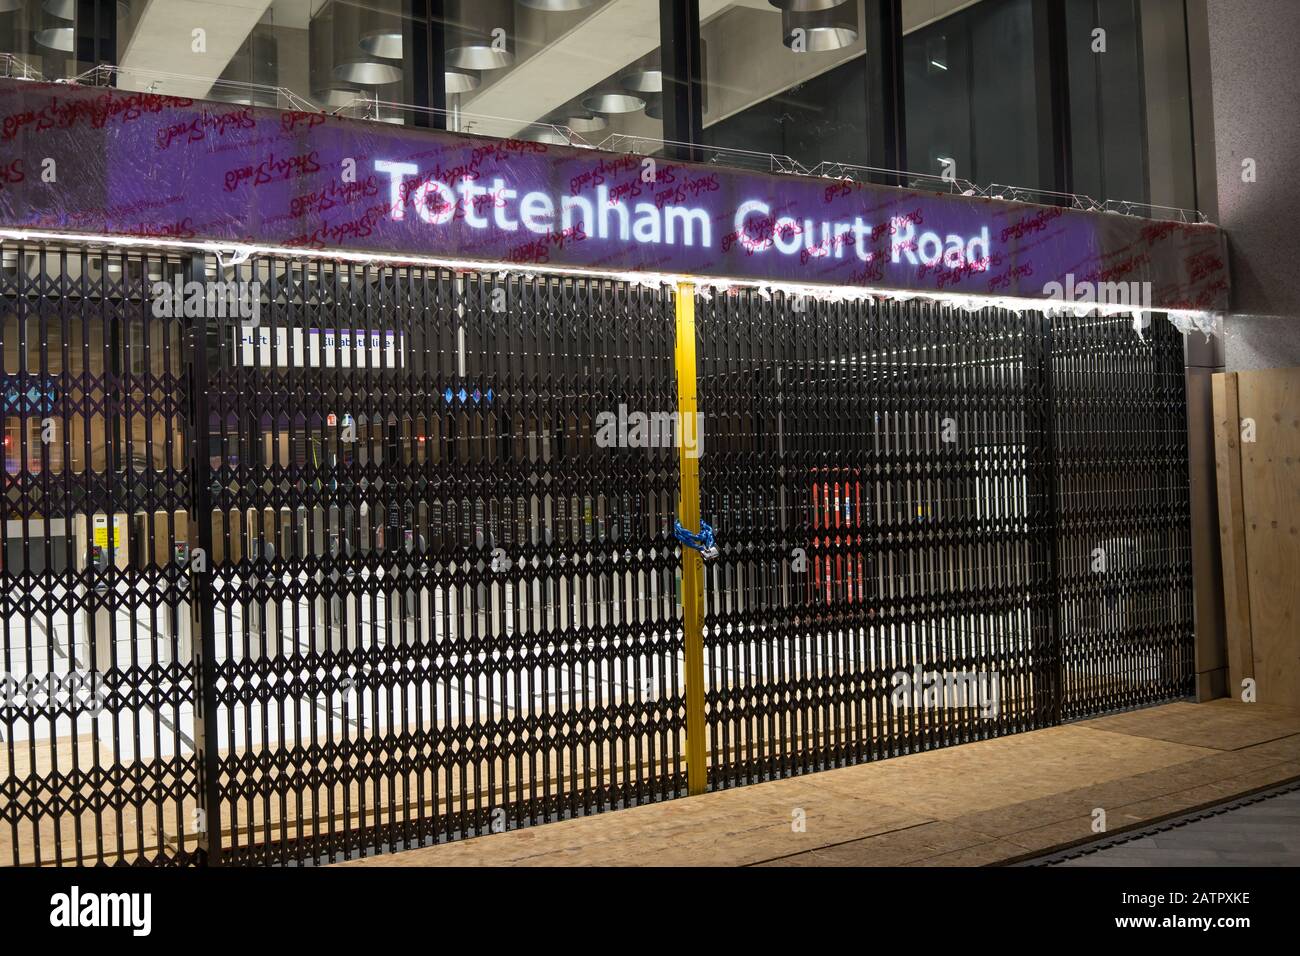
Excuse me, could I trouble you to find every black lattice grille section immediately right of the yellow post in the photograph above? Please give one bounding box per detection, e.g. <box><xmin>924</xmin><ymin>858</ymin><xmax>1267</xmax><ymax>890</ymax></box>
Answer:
<box><xmin>698</xmin><ymin>293</ymin><xmax>1057</xmax><ymax>786</ymax></box>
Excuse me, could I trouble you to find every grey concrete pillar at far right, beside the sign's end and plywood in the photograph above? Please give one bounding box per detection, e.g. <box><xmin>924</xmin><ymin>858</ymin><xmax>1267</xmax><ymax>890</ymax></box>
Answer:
<box><xmin>1187</xmin><ymin>0</ymin><xmax>1300</xmax><ymax>698</ymax></box>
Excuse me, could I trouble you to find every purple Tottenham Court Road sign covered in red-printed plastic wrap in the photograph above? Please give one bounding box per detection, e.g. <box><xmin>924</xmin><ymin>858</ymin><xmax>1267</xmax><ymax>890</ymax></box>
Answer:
<box><xmin>0</xmin><ymin>79</ymin><xmax>1229</xmax><ymax>311</ymax></box>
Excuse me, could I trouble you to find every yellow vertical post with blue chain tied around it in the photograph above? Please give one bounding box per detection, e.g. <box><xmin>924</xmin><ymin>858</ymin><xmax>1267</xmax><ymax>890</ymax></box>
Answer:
<box><xmin>677</xmin><ymin>282</ymin><xmax>707</xmax><ymax>796</ymax></box>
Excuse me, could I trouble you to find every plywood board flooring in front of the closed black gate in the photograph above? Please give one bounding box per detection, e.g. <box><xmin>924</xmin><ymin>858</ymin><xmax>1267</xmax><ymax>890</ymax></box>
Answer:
<box><xmin>339</xmin><ymin>700</ymin><xmax>1300</xmax><ymax>866</ymax></box>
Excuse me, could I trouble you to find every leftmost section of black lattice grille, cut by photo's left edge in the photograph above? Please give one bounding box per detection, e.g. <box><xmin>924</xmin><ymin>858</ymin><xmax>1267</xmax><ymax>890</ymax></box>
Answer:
<box><xmin>0</xmin><ymin>243</ymin><xmax>196</xmax><ymax>865</ymax></box>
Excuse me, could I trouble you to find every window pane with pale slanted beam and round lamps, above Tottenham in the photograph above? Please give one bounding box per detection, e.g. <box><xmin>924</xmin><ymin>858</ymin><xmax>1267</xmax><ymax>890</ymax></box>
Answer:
<box><xmin>441</xmin><ymin>0</ymin><xmax>663</xmax><ymax>151</ymax></box>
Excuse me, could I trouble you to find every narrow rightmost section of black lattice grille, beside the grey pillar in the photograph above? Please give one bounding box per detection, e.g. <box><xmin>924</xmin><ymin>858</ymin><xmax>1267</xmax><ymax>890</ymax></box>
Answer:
<box><xmin>1052</xmin><ymin>317</ymin><xmax>1195</xmax><ymax>719</ymax></box>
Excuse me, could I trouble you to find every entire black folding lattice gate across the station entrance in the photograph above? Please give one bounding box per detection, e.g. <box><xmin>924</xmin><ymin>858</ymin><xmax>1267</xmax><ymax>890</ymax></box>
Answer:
<box><xmin>0</xmin><ymin>246</ymin><xmax>1193</xmax><ymax>864</ymax></box>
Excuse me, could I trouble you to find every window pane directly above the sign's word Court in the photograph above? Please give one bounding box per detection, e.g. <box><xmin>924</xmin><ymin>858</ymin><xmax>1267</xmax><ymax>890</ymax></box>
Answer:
<box><xmin>699</xmin><ymin>0</ymin><xmax>875</xmax><ymax>168</ymax></box>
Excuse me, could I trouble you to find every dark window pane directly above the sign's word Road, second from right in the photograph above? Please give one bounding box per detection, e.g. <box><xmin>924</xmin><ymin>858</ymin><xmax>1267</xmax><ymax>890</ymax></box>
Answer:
<box><xmin>902</xmin><ymin>0</ymin><xmax>1052</xmax><ymax>189</ymax></box>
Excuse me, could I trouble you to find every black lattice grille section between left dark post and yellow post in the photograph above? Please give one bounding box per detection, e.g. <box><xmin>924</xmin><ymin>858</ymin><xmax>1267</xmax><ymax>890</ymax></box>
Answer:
<box><xmin>196</xmin><ymin>260</ymin><xmax>684</xmax><ymax>862</ymax></box>
